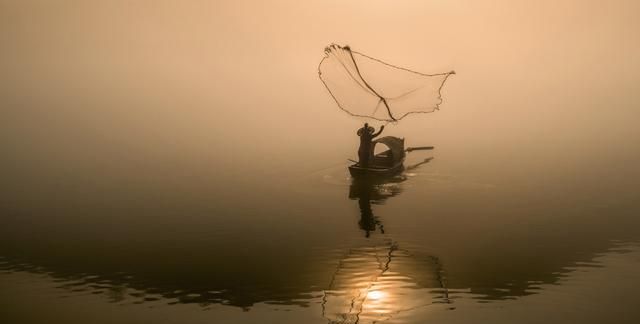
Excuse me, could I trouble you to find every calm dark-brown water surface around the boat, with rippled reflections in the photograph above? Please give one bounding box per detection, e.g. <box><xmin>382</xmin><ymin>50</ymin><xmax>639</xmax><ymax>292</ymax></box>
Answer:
<box><xmin>0</xmin><ymin>151</ymin><xmax>640</xmax><ymax>323</ymax></box>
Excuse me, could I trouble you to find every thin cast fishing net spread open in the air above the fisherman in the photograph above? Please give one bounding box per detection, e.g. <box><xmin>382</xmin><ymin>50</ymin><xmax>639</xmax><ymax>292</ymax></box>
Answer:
<box><xmin>318</xmin><ymin>44</ymin><xmax>455</xmax><ymax>122</ymax></box>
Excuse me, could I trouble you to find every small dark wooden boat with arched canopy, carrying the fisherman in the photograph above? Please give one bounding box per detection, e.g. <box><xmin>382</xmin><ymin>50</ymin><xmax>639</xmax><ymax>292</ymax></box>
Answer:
<box><xmin>349</xmin><ymin>136</ymin><xmax>405</xmax><ymax>177</ymax></box>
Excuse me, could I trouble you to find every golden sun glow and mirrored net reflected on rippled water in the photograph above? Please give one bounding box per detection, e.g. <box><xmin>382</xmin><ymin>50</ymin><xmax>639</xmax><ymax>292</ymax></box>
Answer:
<box><xmin>322</xmin><ymin>240</ymin><xmax>449</xmax><ymax>323</ymax></box>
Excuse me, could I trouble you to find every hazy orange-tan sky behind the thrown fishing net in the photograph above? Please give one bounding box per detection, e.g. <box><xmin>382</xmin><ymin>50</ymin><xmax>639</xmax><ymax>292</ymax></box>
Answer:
<box><xmin>0</xmin><ymin>0</ymin><xmax>640</xmax><ymax>182</ymax></box>
